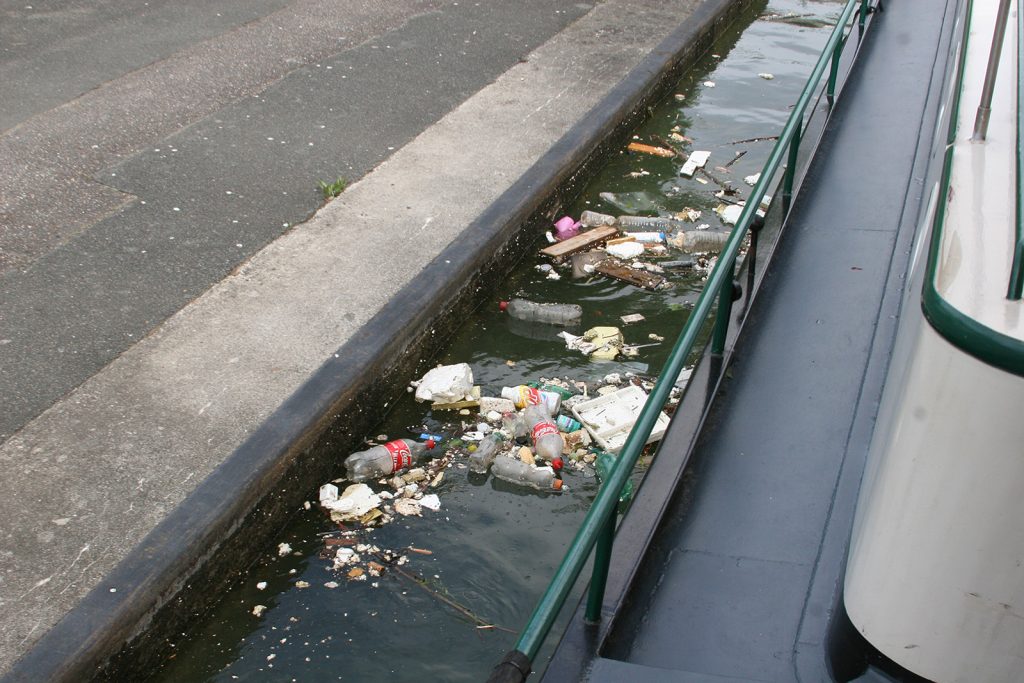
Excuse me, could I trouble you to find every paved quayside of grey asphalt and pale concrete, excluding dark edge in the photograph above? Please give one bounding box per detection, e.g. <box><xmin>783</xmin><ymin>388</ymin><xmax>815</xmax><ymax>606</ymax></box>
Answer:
<box><xmin>0</xmin><ymin>0</ymin><xmax>701</xmax><ymax>675</ymax></box>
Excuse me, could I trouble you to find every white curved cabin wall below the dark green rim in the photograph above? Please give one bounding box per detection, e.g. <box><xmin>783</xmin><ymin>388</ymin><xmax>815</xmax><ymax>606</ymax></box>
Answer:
<box><xmin>845</xmin><ymin>308</ymin><xmax>1024</xmax><ymax>683</ymax></box>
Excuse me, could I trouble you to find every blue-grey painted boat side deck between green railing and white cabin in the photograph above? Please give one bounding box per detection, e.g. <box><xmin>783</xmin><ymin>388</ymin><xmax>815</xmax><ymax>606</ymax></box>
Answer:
<box><xmin>546</xmin><ymin>0</ymin><xmax>955</xmax><ymax>681</ymax></box>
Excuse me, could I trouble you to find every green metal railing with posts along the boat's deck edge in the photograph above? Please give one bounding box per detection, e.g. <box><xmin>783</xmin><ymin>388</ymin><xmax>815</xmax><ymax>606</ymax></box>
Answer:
<box><xmin>490</xmin><ymin>0</ymin><xmax>871</xmax><ymax>681</ymax></box>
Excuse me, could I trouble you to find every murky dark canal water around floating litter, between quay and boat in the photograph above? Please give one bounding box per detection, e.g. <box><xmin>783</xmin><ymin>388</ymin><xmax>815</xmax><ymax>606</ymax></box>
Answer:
<box><xmin>155</xmin><ymin>0</ymin><xmax>841</xmax><ymax>682</ymax></box>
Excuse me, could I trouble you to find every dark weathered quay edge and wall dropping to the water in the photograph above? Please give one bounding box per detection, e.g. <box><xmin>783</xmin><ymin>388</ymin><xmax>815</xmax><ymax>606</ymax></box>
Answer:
<box><xmin>2</xmin><ymin>0</ymin><xmax>757</xmax><ymax>683</ymax></box>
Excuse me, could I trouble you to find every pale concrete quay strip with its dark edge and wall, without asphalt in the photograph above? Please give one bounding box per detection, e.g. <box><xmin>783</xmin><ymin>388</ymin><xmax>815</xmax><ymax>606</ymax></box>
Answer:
<box><xmin>0</xmin><ymin>0</ymin><xmax>761</xmax><ymax>680</ymax></box>
